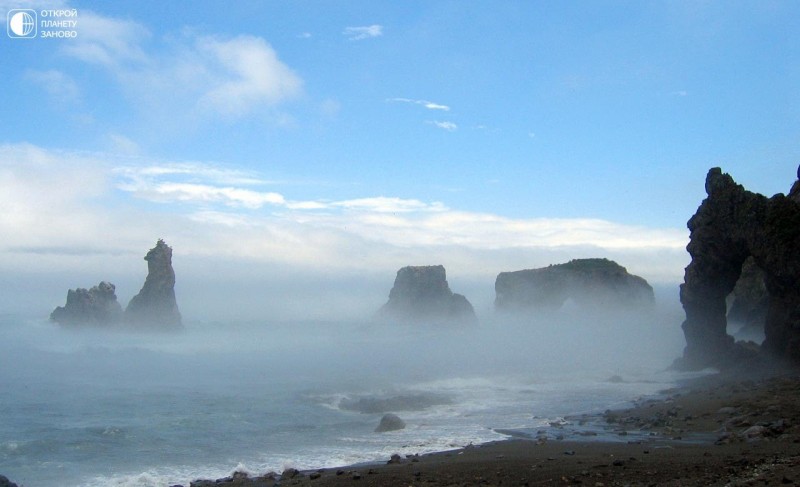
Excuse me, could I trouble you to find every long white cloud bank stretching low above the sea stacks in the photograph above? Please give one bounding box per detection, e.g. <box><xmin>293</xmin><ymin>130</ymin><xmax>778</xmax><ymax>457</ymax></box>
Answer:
<box><xmin>0</xmin><ymin>144</ymin><xmax>687</xmax><ymax>286</ymax></box>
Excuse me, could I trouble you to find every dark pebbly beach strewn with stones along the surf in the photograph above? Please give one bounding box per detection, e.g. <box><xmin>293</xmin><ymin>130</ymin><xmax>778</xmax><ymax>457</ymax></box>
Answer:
<box><xmin>184</xmin><ymin>370</ymin><xmax>800</xmax><ymax>487</ymax></box>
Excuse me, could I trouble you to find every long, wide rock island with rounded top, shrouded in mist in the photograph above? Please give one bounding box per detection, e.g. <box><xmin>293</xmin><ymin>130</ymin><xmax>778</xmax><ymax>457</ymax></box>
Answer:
<box><xmin>494</xmin><ymin>259</ymin><xmax>654</xmax><ymax>312</ymax></box>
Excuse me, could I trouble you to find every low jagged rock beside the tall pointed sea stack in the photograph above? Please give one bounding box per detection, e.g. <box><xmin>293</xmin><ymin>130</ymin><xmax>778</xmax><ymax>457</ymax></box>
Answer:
<box><xmin>50</xmin><ymin>281</ymin><xmax>122</xmax><ymax>326</ymax></box>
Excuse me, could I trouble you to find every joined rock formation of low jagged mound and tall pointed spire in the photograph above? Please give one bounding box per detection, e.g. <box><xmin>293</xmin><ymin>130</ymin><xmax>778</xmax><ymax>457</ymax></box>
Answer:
<box><xmin>50</xmin><ymin>239</ymin><xmax>182</xmax><ymax>329</ymax></box>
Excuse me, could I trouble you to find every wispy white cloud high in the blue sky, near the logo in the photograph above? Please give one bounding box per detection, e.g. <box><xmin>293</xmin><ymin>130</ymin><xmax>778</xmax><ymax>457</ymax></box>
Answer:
<box><xmin>60</xmin><ymin>10</ymin><xmax>303</xmax><ymax>122</ymax></box>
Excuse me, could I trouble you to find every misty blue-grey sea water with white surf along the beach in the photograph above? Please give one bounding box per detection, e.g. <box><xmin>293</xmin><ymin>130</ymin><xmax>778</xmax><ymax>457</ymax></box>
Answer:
<box><xmin>0</xmin><ymin>316</ymin><xmax>681</xmax><ymax>487</ymax></box>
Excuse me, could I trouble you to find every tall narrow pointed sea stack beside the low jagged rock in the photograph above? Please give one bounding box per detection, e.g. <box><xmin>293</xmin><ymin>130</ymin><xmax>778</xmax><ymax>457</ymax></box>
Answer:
<box><xmin>125</xmin><ymin>239</ymin><xmax>182</xmax><ymax>329</ymax></box>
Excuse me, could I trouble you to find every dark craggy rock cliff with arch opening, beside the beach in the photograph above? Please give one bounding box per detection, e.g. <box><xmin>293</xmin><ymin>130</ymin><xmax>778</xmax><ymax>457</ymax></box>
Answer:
<box><xmin>676</xmin><ymin>168</ymin><xmax>800</xmax><ymax>368</ymax></box>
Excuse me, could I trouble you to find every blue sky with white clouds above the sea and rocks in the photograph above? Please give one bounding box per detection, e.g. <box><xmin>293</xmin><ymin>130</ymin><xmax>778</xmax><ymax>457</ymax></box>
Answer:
<box><xmin>0</xmin><ymin>0</ymin><xmax>800</xmax><ymax>320</ymax></box>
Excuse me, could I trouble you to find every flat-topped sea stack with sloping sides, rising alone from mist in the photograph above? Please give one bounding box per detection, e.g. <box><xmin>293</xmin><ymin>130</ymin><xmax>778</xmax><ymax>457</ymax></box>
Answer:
<box><xmin>378</xmin><ymin>265</ymin><xmax>477</xmax><ymax>324</ymax></box>
